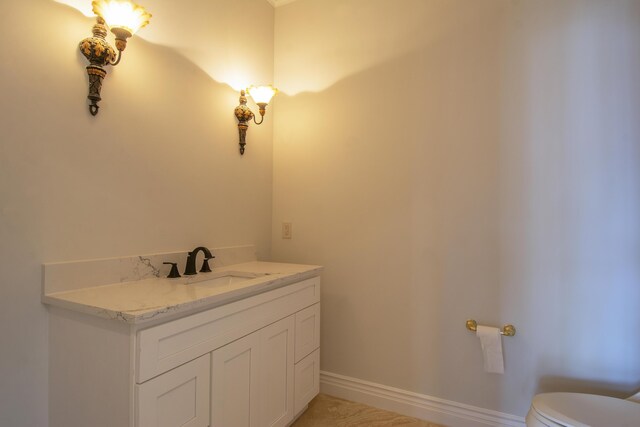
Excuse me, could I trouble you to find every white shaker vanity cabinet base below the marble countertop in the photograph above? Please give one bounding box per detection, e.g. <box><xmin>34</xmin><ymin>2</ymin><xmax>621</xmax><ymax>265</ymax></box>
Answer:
<box><xmin>50</xmin><ymin>277</ymin><xmax>320</xmax><ymax>427</ymax></box>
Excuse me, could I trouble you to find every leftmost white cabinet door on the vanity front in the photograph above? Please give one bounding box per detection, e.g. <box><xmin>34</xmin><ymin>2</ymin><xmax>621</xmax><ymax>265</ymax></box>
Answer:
<box><xmin>136</xmin><ymin>354</ymin><xmax>210</xmax><ymax>427</ymax></box>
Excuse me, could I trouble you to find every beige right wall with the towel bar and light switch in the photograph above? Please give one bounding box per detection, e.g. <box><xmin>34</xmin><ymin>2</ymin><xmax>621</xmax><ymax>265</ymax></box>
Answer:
<box><xmin>272</xmin><ymin>0</ymin><xmax>640</xmax><ymax>416</ymax></box>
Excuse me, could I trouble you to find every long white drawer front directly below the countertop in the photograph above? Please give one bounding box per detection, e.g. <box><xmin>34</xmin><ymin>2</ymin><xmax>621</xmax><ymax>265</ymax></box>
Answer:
<box><xmin>136</xmin><ymin>277</ymin><xmax>320</xmax><ymax>383</ymax></box>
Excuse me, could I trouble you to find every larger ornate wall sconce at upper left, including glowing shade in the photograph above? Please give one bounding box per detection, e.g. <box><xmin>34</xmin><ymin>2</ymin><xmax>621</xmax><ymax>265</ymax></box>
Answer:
<box><xmin>79</xmin><ymin>0</ymin><xmax>151</xmax><ymax>116</ymax></box>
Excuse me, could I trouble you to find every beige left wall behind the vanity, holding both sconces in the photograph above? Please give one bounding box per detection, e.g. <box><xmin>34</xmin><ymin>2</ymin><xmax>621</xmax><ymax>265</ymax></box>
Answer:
<box><xmin>0</xmin><ymin>0</ymin><xmax>274</xmax><ymax>427</ymax></box>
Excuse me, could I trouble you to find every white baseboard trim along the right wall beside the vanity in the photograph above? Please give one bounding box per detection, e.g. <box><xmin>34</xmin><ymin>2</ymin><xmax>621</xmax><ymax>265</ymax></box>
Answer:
<box><xmin>320</xmin><ymin>371</ymin><xmax>526</xmax><ymax>427</ymax></box>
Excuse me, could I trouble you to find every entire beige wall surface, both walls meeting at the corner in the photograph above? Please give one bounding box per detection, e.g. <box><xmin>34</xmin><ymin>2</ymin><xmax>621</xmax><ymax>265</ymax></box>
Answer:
<box><xmin>0</xmin><ymin>0</ymin><xmax>640</xmax><ymax>426</ymax></box>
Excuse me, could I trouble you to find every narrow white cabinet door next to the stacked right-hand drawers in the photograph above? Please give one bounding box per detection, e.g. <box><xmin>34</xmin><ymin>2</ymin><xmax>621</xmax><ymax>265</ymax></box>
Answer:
<box><xmin>259</xmin><ymin>316</ymin><xmax>295</xmax><ymax>427</ymax></box>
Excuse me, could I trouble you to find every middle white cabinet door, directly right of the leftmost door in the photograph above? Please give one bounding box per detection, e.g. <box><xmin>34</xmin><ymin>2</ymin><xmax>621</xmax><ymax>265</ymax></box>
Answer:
<box><xmin>211</xmin><ymin>331</ymin><xmax>261</xmax><ymax>427</ymax></box>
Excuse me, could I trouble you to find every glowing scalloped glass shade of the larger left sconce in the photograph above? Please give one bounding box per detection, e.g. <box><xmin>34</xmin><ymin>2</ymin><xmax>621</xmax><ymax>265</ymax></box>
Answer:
<box><xmin>91</xmin><ymin>0</ymin><xmax>151</xmax><ymax>38</ymax></box>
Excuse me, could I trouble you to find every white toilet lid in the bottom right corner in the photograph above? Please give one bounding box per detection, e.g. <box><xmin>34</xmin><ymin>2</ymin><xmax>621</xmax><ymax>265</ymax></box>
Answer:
<box><xmin>531</xmin><ymin>393</ymin><xmax>640</xmax><ymax>427</ymax></box>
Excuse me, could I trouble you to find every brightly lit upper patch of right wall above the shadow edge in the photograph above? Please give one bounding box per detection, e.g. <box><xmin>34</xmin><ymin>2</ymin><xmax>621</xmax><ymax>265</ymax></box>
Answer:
<box><xmin>275</xmin><ymin>0</ymin><xmax>504</xmax><ymax>95</ymax></box>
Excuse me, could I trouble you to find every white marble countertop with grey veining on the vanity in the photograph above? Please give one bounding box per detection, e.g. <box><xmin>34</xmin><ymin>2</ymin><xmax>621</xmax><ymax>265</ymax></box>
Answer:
<box><xmin>42</xmin><ymin>261</ymin><xmax>322</xmax><ymax>324</ymax></box>
